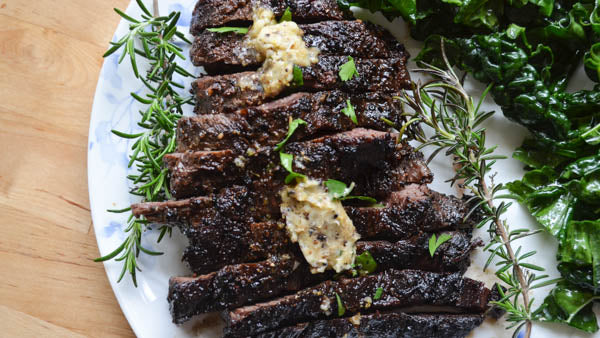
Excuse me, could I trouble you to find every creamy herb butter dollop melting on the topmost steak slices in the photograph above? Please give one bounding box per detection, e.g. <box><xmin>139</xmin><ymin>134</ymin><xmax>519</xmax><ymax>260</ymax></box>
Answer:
<box><xmin>238</xmin><ymin>7</ymin><xmax>319</xmax><ymax>96</ymax></box>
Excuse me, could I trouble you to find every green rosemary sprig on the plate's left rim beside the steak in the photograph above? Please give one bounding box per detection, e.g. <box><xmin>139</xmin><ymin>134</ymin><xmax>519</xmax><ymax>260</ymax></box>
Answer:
<box><xmin>95</xmin><ymin>0</ymin><xmax>193</xmax><ymax>286</ymax></box>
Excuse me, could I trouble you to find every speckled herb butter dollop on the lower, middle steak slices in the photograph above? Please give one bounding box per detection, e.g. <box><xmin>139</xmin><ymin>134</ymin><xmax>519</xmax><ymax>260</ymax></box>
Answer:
<box><xmin>280</xmin><ymin>179</ymin><xmax>360</xmax><ymax>273</ymax></box>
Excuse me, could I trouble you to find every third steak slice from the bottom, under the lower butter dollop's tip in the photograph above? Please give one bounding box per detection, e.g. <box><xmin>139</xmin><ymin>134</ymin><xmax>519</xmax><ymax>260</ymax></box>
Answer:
<box><xmin>168</xmin><ymin>232</ymin><xmax>473</xmax><ymax>323</ymax></box>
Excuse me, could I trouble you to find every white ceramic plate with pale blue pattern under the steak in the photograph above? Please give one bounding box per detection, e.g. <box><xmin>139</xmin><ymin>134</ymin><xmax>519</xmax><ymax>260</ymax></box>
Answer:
<box><xmin>88</xmin><ymin>0</ymin><xmax>600</xmax><ymax>338</ymax></box>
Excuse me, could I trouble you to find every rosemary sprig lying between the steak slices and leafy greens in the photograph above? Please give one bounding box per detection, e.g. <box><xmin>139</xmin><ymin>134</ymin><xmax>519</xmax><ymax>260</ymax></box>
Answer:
<box><xmin>399</xmin><ymin>41</ymin><xmax>557</xmax><ymax>338</ymax></box>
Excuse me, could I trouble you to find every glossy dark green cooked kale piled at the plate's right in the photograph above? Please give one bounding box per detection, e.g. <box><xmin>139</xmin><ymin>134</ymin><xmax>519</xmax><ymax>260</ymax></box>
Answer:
<box><xmin>339</xmin><ymin>0</ymin><xmax>600</xmax><ymax>332</ymax></box>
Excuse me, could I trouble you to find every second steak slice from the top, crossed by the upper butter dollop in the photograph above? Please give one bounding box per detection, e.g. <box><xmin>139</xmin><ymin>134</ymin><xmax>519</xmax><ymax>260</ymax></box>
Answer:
<box><xmin>190</xmin><ymin>20</ymin><xmax>406</xmax><ymax>74</ymax></box>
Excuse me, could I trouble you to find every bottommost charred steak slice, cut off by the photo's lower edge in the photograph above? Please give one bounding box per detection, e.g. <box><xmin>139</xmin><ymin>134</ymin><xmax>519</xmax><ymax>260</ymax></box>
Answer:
<box><xmin>257</xmin><ymin>311</ymin><xmax>484</xmax><ymax>338</ymax></box>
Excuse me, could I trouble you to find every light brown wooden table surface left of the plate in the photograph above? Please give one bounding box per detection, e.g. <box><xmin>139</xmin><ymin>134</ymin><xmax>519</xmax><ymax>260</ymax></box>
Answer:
<box><xmin>0</xmin><ymin>0</ymin><xmax>133</xmax><ymax>337</ymax></box>
